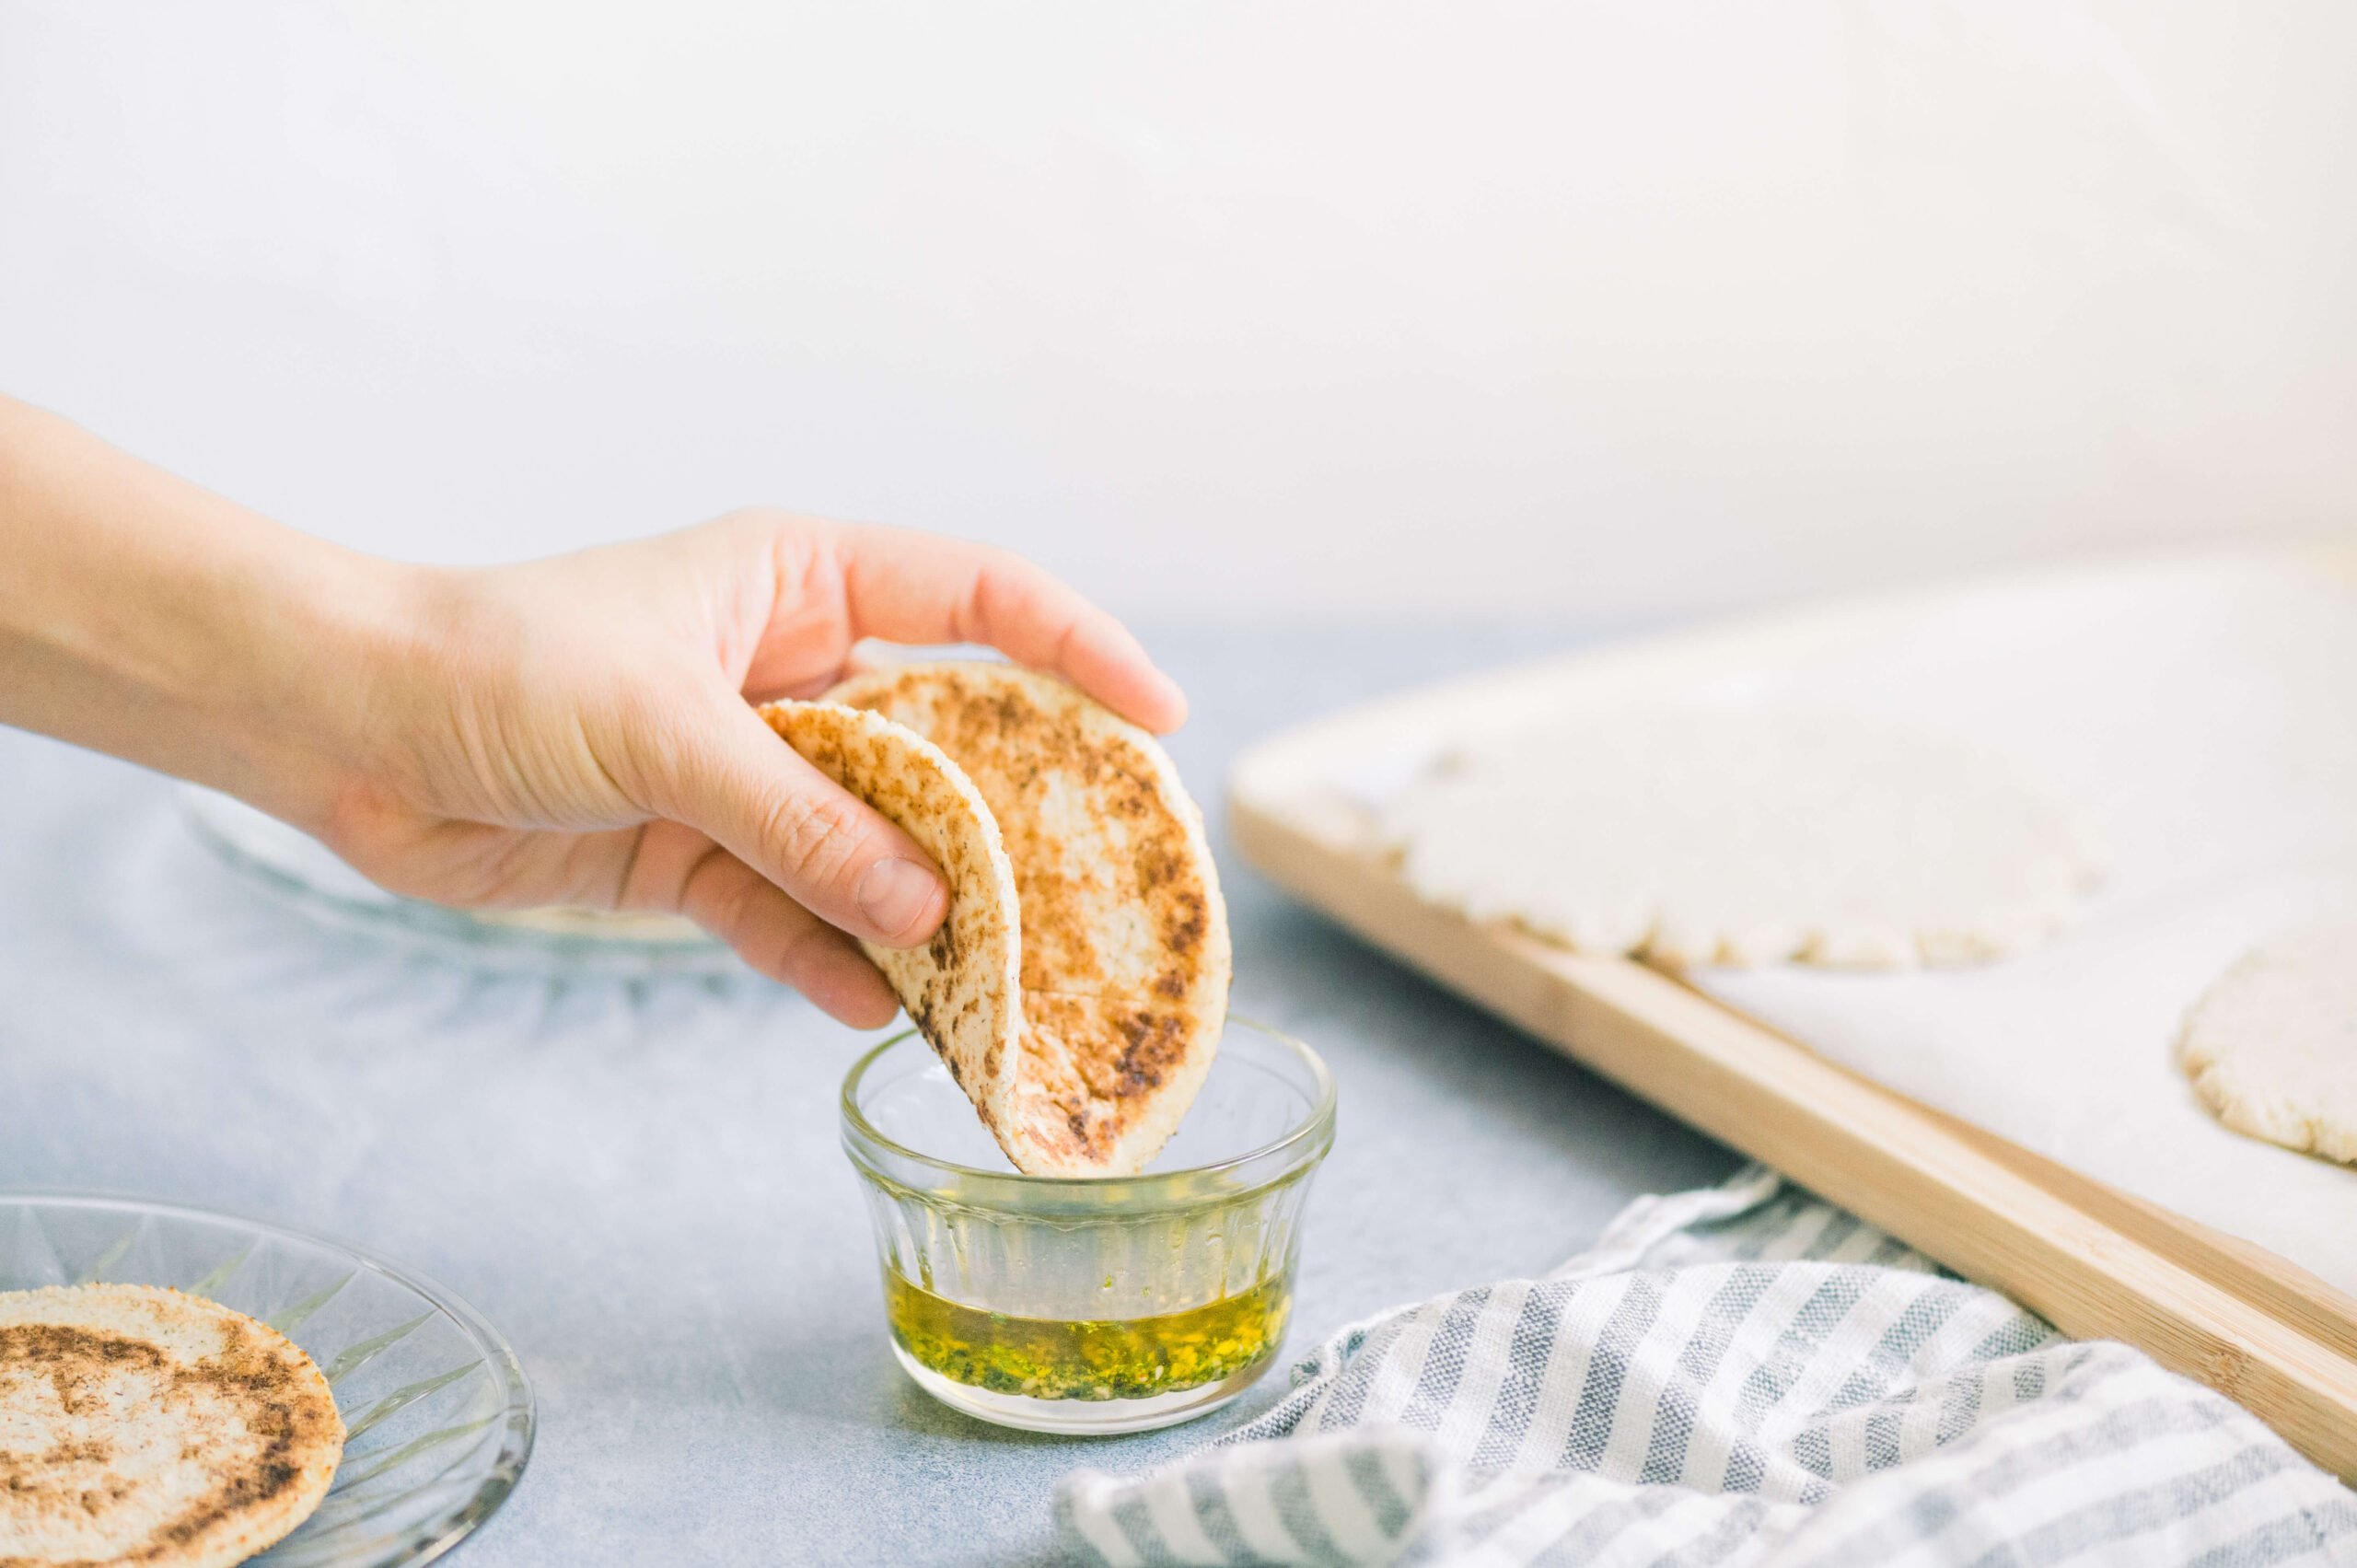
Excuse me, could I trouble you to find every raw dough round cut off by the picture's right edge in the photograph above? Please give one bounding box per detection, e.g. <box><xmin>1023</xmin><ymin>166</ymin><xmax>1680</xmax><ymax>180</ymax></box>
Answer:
<box><xmin>2177</xmin><ymin>917</ymin><xmax>2357</xmax><ymax>1165</ymax></box>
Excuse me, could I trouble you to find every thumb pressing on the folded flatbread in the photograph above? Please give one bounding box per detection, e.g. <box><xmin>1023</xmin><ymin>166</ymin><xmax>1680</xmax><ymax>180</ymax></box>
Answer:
<box><xmin>657</xmin><ymin>693</ymin><xmax>950</xmax><ymax>947</ymax></box>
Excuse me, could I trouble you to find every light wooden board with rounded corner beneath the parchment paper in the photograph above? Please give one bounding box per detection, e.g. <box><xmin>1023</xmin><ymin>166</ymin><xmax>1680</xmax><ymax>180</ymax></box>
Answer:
<box><xmin>1228</xmin><ymin>556</ymin><xmax>2357</xmax><ymax>1483</ymax></box>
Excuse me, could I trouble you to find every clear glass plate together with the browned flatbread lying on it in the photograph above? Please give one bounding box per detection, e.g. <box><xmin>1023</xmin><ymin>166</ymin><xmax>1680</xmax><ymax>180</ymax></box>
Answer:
<box><xmin>0</xmin><ymin>1189</ymin><xmax>535</xmax><ymax>1568</ymax></box>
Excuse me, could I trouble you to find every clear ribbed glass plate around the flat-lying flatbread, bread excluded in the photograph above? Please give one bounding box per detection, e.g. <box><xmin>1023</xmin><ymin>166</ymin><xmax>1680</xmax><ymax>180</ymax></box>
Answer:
<box><xmin>0</xmin><ymin>1191</ymin><xmax>533</xmax><ymax>1568</ymax></box>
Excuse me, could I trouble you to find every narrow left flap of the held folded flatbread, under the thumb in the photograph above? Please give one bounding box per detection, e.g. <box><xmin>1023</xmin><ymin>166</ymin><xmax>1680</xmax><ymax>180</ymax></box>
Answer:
<box><xmin>761</xmin><ymin>703</ymin><xmax>1023</xmax><ymax>1117</ymax></box>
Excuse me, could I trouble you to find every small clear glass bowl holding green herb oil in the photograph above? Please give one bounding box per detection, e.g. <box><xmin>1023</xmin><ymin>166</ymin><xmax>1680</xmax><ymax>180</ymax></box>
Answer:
<box><xmin>843</xmin><ymin>1018</ymin><xmax>1334</xmax><ymax>1434</ymax></box>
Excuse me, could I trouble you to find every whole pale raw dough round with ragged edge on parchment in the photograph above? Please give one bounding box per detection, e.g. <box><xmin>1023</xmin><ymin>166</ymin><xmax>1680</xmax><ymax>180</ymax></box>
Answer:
<box><xmin>1384</xmin><ymin>703</ymin><xmax>2100</xmax><ymax>970</ymax></box>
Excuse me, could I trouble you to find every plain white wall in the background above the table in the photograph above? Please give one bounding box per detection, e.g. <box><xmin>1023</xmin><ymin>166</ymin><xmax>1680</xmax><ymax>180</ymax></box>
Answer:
<box><xmin>0</xmin><ymin>0</ymin><xmax>2357</xmax><ymax>618</ymax></box>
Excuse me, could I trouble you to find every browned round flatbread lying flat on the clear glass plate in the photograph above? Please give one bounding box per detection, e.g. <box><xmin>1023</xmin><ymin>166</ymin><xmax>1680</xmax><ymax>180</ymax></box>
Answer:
<box><xmin>0</xmin><ymin>1285</ymin><xmax>344</xmax><ymax>1568</ymax></box>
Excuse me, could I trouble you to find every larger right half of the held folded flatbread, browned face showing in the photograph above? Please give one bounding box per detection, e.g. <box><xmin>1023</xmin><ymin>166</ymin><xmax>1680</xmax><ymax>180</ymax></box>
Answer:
<box><xmin>828</xmin><ymin>663</ymin><xmax>1230</xmax><ymax>1177</ymax></box>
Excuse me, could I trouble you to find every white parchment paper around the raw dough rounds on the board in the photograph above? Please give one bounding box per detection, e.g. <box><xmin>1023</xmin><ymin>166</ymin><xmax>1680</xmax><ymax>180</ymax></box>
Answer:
<box><xmin>1363</xmin><ymin>556</ymin><xmax>2357</xmax><ymax>1292</ymax></box>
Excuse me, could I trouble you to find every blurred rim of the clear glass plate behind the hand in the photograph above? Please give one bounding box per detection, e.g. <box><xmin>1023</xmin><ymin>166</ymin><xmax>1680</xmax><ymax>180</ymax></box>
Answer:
<box><xmin>180</xmin><ymin>785</ymin><xmax>737</xmax><ymax>976</ymax></box>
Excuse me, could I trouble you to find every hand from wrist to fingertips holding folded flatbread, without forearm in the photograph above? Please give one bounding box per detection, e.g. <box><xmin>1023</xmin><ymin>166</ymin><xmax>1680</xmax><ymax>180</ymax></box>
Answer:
<box><xmin>316</xmin><ymin>512</ymin><xmax>1186</xmax><ymax>1028</ymax></box>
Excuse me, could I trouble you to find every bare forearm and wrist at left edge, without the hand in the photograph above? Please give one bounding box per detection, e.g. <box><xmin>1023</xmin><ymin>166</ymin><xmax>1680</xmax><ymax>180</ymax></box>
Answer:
<box><xmin>0</xmin><ymin>399</ymin><xmax>443</xmax><ymax>828</ymax></box>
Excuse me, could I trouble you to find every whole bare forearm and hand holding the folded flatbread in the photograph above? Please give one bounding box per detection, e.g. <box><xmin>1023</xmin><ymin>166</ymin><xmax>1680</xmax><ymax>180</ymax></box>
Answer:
<box><xmin>0</xmin><ymin>399</ymin><xmax>1186</xmax><ymax>1026</ymax></box>
